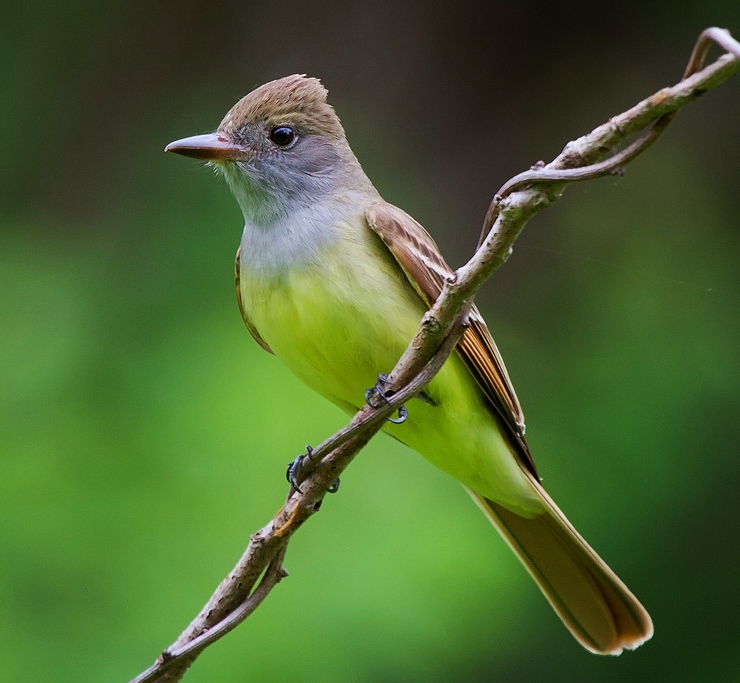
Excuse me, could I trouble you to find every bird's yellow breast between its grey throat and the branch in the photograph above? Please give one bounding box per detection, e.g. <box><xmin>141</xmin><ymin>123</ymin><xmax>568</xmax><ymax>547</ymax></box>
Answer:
<box><xmin>240</xmin><ymin>220</ymin><xmax>424</xmax><ymax>410</ymax></box>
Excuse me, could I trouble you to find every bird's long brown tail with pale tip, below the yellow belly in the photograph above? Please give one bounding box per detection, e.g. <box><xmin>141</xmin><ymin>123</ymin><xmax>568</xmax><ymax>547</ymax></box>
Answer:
<box><xmin>468</xmin><ymin>477</ymin><xmax>653</xmax><ymax>655</ymax></box>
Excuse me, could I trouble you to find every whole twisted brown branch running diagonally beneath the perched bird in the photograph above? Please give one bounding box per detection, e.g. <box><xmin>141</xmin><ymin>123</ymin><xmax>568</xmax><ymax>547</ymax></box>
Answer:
<box><xmin>132</xmin><ymin>28</ymin><xmax>740</xmax><ymax>683</ymax></box>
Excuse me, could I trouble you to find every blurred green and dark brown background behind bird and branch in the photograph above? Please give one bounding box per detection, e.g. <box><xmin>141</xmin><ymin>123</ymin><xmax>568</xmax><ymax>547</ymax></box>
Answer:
<box><xmin>0</xmin><ymin>0</ymin><xmax>740</xmax><ymax>683</ymax></box>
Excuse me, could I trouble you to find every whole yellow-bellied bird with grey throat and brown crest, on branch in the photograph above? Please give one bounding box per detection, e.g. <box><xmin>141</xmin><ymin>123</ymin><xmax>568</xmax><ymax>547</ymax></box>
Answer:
<box><xmin>166</xmin><ymin>75</ymin><xmax>653</xmax><ymax>654</ymax></box>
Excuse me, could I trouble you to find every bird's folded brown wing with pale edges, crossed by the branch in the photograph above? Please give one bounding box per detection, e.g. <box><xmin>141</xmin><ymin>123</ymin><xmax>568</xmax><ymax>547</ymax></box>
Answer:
<box><xmin>365</xmin><ymin>202</ymin><xmax>537</xmax><ymax>476</ymax></box>
